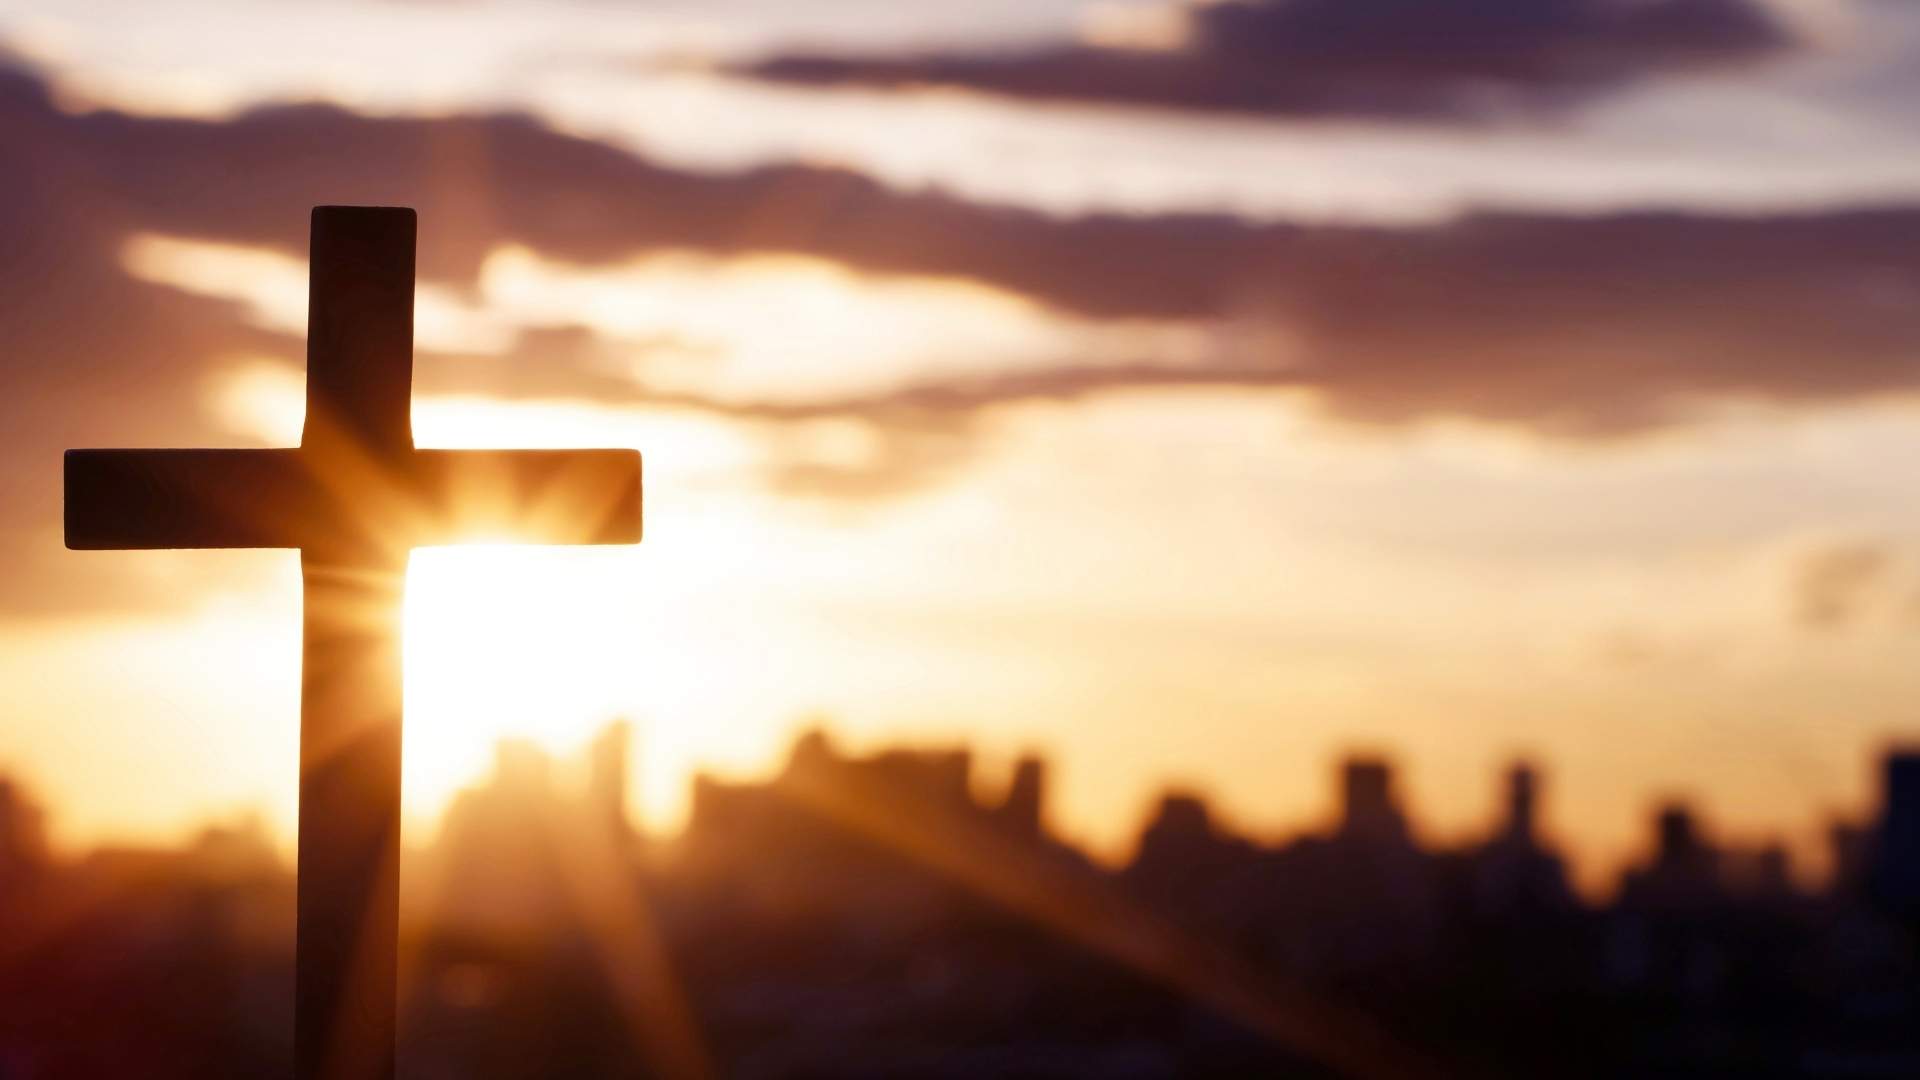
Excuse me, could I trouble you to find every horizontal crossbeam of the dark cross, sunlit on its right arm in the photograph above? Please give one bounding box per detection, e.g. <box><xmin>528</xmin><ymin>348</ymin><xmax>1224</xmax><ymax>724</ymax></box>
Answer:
<box><xmin>65</xmin><ymin>448</ymin><xmax>641</xmax><ymax>559</ymax></box>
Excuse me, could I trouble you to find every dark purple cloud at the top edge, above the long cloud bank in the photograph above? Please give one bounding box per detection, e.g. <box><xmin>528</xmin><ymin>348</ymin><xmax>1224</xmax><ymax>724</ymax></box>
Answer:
<box><xmin>745</xmin><ymin>0</ymin><xmax>1793</xmax><ymax>119</ymax></box>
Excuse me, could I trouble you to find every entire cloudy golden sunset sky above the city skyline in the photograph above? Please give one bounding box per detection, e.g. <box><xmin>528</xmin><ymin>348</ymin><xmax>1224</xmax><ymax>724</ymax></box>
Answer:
<box><xmin>0</xmin><ymin>0</ymin><xmax>1920</xmax><ymax>882</ymax></box>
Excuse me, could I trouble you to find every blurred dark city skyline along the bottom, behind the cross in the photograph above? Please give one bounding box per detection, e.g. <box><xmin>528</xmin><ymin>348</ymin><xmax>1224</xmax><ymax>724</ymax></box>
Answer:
<box><xmin>0</xmin><ymin>723</ymin><xmax>1920</xmax><ymax>1078</ymax></box>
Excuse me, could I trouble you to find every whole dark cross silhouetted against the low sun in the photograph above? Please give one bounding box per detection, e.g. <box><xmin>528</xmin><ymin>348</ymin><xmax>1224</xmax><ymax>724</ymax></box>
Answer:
<box><xmin>65</xmin><ymin>206</ymin><xmax>639</xmax><ymax>1080</ymax></box>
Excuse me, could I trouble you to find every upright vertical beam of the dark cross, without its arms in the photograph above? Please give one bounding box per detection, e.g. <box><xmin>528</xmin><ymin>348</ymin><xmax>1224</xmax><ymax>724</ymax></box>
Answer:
<box><xmin>294</xmin><ymin>206</ymin><xmax>415</xmax><ymax>1080</ymax></box>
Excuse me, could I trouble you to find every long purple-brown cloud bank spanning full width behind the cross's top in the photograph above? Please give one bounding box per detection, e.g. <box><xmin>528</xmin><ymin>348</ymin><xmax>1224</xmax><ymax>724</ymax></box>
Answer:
<box><xmin>11</xmin><ymin>58</ymin><xmax>1920</xmax><ymax>603</ymax></box>
